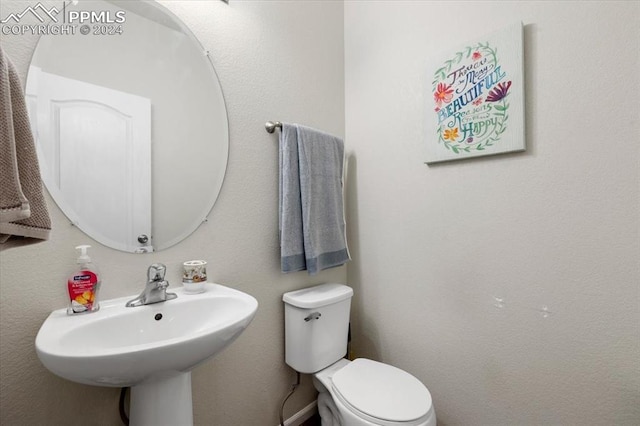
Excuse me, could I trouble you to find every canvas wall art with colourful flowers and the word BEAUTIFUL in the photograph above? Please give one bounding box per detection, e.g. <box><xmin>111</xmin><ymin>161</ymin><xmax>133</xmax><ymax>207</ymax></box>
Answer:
<box><xmin>426</xmin><ymin>23</ymin><xmax>525</xmax><ymax>163</ymax></box>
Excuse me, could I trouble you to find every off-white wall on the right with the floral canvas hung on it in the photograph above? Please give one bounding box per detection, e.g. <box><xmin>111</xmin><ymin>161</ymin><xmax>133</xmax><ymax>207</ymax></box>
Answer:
<box><xmin>345</xmin><ymin>1</ymin><xmax>640</xmax><ymax>426</ymax></box>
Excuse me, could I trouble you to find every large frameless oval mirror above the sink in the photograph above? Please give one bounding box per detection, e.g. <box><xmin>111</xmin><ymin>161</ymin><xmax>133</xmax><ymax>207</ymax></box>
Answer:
<box><xmin>26</xmin><ymin>0</ymin><xmax>229</xmax><ymax>253</ymax></box>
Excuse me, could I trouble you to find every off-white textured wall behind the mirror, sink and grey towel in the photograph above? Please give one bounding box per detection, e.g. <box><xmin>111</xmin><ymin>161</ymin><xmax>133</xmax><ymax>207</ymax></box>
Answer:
<box><xmin>0</xmin><ymin>0</ymin><xmax>346</xmax><ymax>426</ymax></box>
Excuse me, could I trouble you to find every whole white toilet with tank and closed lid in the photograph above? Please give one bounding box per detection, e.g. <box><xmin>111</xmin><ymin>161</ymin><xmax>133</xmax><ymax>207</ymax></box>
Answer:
<box><xmin>282</xmin><ymin>284</ymin><xmax>436</xmax><ymax>426</ymax></box>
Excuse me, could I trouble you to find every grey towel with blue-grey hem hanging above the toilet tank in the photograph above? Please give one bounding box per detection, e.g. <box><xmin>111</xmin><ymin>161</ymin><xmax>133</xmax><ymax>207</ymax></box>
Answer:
<box><xmin>280</xmin><ymin>123</ymin><xmax>350</xmax><ymax>274</ymax></box>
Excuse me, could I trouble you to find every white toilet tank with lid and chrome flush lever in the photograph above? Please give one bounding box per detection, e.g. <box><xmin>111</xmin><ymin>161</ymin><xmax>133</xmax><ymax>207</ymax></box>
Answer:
<box><xmin>282</xmin><ymin>284</ymin><xmax>353</xmax><ymax>373</ymax></box>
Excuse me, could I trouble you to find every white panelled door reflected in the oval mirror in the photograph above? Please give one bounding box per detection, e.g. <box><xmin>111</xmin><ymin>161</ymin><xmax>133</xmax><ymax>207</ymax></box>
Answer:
<box><xmin>27</xmin><ymin>67</ymin><xmax>153</xmax><ymax>252</ymax></box>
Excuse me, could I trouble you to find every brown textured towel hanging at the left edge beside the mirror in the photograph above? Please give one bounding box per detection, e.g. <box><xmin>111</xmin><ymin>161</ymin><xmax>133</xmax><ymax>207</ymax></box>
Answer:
<box><xmin>0</xmin><ymin>46</ymin><xmax>51</xmax><ymax>250</ymax></box>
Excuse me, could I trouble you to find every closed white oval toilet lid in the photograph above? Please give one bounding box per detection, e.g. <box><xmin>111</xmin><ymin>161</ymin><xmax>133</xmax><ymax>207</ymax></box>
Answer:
<box><xmin>332</xmin><ymin>358</ymin><xmax>431</xmax><ymax>422</ymax></box>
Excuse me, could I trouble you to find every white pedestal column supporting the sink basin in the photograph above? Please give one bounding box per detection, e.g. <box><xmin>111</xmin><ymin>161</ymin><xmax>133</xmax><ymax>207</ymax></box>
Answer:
<box><xmin>129</xmin><ymin>372</ymin><xmax>193</xmax><ymax>426</ymax></box>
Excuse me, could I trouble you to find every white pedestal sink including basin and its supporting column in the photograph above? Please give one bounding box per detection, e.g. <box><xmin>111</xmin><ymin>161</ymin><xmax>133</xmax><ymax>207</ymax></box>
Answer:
<box><xmin>36</xmin><ymin>284</ymin><xmax>258</xmax><ymax>426</ymax></box>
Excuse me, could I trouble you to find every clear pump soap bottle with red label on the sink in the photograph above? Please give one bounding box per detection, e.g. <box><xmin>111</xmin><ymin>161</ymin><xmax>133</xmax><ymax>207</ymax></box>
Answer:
<box><xmin>67</xmin><ymin>245</ymin><xmax>101</xmax><ymax>315</ymax></box>
